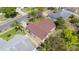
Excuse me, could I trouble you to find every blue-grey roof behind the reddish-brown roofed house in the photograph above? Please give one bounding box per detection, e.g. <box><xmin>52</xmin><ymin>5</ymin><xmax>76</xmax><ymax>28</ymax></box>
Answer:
<box><xmin>48</xmin><ymin>9</ymin><xmax>72</xmax><ymax>19</ymax></box>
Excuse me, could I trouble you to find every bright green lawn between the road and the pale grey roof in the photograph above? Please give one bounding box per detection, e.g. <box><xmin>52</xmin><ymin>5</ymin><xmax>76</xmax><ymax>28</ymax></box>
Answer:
<box><xmin>0</xmin><ymin>27</ymin><xmax>25</xmax><ymax>41</ymax></box>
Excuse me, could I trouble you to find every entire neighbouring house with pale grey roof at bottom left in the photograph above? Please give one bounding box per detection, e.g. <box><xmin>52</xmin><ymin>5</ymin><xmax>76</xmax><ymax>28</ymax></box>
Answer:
<box><xmin>0</xmin><ymin>35</ymin><xmax>35</xmax><ymax>51</ymax></box>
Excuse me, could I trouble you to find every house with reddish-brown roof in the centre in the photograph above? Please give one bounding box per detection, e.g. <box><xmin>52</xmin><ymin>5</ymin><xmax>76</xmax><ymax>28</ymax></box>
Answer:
<box><xmin>27</xmin><ymin>18</ymin><xmax>55</xmax><ymax>42</ymax></box>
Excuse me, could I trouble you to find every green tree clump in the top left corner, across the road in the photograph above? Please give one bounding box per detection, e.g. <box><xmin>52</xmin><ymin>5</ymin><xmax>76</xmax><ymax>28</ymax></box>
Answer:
<box><xmin>0</xmin><ymin>7</ymin><xmax>17</xmax><ymax>18</ymax></box>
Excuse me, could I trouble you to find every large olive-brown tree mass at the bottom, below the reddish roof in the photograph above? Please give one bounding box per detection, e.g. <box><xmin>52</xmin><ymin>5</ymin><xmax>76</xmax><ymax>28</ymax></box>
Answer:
<box><xmin>37</xmin><ymin>36</ymin><xmax>66</xmax><ymax>51</ymax></box>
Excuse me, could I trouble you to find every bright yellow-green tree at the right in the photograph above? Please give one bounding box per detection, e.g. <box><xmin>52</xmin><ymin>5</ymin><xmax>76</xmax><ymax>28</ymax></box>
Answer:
<box><xmin>64</xmin><ymin>29</ymin><xmax>78</xmax><ymax>50</ymax></box>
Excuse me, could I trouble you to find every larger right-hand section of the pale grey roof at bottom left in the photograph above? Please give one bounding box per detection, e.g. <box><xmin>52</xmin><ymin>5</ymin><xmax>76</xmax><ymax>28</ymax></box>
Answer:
<box><xmin>9</xmin><ymin>35</ymin><xmax>34</xmax><ymax>51</ymax></box>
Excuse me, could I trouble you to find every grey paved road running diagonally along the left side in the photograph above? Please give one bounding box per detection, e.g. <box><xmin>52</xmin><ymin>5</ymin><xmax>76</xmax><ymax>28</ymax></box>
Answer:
<box><xmin>0</xmin><ymin>15</ymin><xmax>28</xmax><ymax>31</ymax></box>
